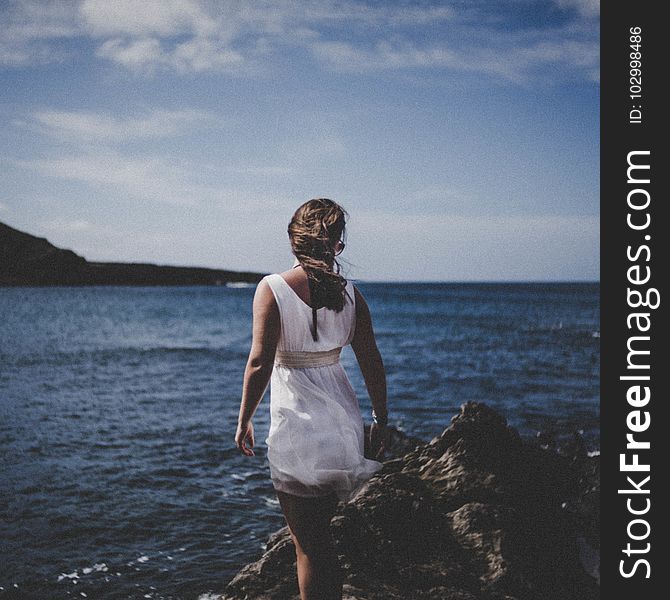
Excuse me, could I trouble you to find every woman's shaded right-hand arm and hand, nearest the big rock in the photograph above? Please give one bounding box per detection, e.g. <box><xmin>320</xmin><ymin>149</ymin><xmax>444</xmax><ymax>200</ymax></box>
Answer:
<box><xmin>351</xmin><ymin>286</ymin><xmax>389</xmax><ymax>458</ymax></box>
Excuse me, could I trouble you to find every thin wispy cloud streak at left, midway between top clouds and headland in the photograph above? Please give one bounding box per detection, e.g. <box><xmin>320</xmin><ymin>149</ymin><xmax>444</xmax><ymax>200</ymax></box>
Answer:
<box><xmin>32</xmin><ymin>110</ymin><xmax>215</xmax><ymax>142</ymax></box>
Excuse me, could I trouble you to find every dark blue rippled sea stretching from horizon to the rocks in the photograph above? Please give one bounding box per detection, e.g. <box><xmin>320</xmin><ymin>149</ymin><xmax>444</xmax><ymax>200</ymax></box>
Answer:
<box><xmin>0</xmin><ymin>281</ymin><xmax>600</xmax><ymax>600</ymax></box>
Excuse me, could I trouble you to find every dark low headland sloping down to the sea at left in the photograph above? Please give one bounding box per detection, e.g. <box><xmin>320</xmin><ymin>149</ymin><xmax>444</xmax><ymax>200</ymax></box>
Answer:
<box><xmin>0</xmin><ymin>223</ymin><xmax>265</xmax><ymax>286</ymax></box>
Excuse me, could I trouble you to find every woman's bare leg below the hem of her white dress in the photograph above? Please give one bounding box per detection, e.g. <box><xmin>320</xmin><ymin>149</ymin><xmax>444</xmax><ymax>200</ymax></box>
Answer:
<box><xmin>277</xmin><ymin>490</ymin><xmax>342</xmax><ymax>600</ymax></box>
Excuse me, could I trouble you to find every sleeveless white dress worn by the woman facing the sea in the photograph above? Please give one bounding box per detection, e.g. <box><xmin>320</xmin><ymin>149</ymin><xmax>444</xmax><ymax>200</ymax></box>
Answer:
<box><xmin>263</xmin><ymin>273</ymin><xmax>382</xmax><ymax>501</ymax></box>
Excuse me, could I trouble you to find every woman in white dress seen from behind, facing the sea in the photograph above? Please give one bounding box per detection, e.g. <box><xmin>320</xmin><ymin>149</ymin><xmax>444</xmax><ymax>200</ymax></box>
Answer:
<box><xmin>235</xmin><ymin>198</ymin><xmax>388</xmax><ymax>600</ymax></box>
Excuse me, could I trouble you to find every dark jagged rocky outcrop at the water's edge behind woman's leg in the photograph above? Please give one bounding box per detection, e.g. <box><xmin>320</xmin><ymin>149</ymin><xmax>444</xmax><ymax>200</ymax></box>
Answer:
<box><xmin>221</xmin><ymin>403</ymin><xmax>599</xmax><ymax>600</ymax></box>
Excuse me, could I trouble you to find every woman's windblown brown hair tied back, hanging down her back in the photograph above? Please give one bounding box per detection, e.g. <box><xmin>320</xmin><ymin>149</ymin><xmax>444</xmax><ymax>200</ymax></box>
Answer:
<box><xmin>288</xmin><ymin>198</ymin><xmax>348</xmax><ymax>340</ymax></box>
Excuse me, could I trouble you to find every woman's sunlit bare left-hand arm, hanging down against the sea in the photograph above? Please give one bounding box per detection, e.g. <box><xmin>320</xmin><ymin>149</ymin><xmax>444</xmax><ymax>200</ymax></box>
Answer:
<box><xmin>235</xmin><ymin>281</ymin><xmax>281</xmax><ymax>456</ymax></box>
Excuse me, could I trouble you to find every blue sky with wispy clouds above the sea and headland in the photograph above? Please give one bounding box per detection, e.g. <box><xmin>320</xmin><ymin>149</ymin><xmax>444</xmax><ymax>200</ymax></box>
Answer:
<box><xmin>0</xmin><ymin>0</ymin><xmax>600</xmax><ymax>281</ymax></box>
